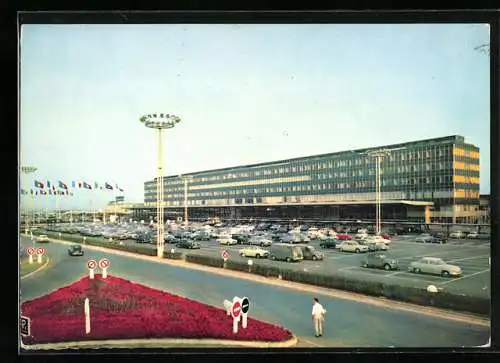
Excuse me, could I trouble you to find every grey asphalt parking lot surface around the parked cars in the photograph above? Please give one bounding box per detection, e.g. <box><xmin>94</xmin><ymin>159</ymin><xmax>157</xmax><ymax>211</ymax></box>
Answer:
<box><xmin>112</xmin><ymin>236</ymin><xmax>491</xmax><ymax>297</ymax></box>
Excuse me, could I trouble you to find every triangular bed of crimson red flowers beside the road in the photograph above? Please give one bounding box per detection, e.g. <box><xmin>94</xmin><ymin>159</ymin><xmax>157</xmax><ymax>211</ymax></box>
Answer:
<box><xmin>21</xmin><ymin>274</ymin><xmax>292</xmax><ymax>345</ymax></box>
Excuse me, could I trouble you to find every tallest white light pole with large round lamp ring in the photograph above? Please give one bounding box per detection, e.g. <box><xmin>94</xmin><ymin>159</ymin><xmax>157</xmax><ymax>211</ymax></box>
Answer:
<box><xmin>139</xmin><ymin>113</ymin><xmax>181</xmax><ymax>258</ymax></box>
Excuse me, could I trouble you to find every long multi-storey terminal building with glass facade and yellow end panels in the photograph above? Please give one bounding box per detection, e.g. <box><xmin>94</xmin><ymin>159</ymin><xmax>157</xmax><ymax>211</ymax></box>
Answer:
<box><xmin>134</xmin><ymin>135</ymin><xmax>479</xmax><ymax>223</ymax></box>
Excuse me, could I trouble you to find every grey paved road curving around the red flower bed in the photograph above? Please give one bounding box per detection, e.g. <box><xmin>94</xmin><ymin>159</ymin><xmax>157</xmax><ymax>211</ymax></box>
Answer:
<box><xmin>21</xmin><ymin>237</ymin><xmax>489</xmax><ymax>347</ymax></box>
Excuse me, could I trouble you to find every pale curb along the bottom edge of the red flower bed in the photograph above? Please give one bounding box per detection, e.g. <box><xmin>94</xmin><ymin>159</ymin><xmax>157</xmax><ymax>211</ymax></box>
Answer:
<box><xmin>21</xmin><ymin>334</ymin><xmax>298</xmax><ymax>350</ymax></box>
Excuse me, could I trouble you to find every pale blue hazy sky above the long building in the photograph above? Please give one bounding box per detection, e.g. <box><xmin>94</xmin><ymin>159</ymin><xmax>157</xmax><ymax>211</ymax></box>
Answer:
<box><xmin>19</xmin><ymin>24</ymin><xmax>490</xmax><ymax>209</ymax></box>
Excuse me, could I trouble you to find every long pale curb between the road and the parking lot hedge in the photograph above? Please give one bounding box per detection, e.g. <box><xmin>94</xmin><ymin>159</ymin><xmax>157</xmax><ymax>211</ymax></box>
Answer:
<box><xmin>41</xmin><ymin>239</ymin><xmax>491</xmax><ymax>327</ymax></box>
